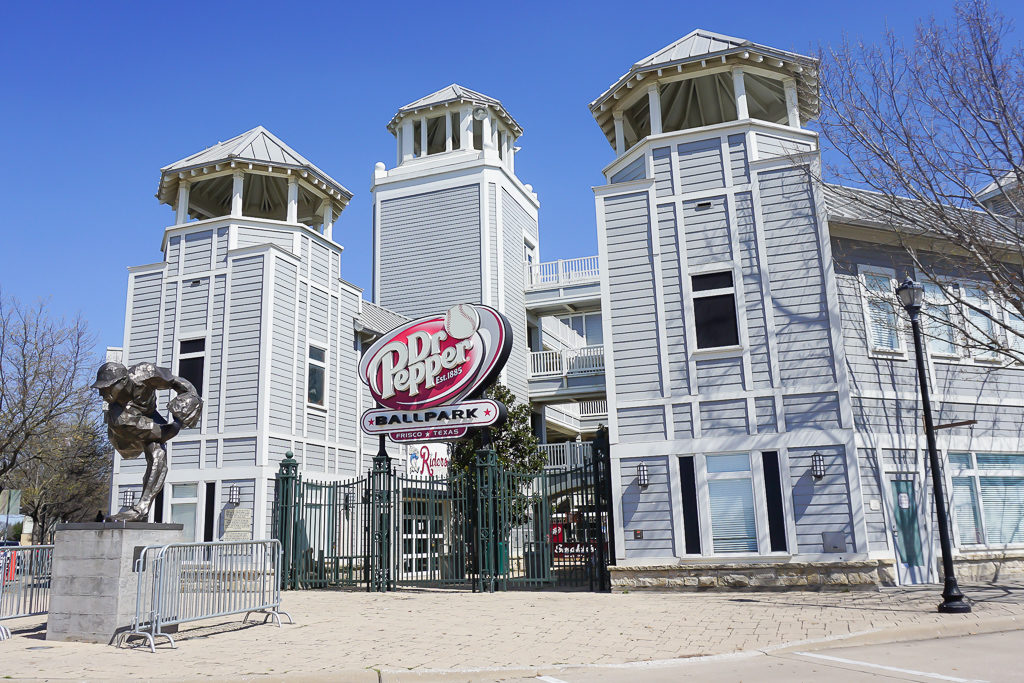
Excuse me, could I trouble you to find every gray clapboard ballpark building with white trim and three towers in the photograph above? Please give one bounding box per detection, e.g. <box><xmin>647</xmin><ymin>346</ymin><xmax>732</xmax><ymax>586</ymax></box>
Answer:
<box><xmin>112</xmin><ymin>31</ymin><xmax>1024</xmax><ymax>587</ymax></box>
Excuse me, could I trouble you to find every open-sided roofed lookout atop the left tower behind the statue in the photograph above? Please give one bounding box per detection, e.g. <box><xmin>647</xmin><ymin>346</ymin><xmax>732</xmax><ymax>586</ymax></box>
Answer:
<box><xmin>157</xmin><ymin>126</ymin><xmax>352</xmax><ymax>240</ymax></box>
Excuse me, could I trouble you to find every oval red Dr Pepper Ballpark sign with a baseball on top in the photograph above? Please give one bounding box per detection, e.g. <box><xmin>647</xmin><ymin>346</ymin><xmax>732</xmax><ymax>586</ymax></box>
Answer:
<box><xmin>359</xmin><ymin>303</ymin><xmax>512</xmax><ymax>441</ymax></box>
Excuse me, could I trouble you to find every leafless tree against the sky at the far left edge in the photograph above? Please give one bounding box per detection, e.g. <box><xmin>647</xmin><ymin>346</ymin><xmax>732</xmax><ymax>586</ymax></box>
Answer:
<box><xmin>0</xmin><ymin>293</ymin><xmax>94</xmax><ymax>476</ymax></box>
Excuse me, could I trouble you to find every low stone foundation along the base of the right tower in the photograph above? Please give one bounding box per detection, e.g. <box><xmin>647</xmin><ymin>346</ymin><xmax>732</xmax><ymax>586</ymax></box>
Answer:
<box><xmin>608</xmin><ymin>560</ymin><xmax>896</xmax><ymax>593</ymax></box>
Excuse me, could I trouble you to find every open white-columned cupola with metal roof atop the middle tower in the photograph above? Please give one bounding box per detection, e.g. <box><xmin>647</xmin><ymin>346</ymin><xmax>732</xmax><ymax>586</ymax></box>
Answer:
<box><xmin>387</xmin><ymin>83</ymin><xmax>522</xmax><ymax>173</ymax></box>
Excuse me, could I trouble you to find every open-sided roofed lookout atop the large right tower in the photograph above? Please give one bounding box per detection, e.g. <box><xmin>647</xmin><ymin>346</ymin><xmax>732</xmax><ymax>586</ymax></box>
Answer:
<box><xmin>590</xmin><ymin>30</ymin><xmax>818</xmax><ymax>156</ymax></box>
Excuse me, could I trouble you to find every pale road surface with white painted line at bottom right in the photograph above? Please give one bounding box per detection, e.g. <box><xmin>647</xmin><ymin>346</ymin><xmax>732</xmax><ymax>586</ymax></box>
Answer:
<box><xmin>520</xmin><ymin>631</ymin><xmax>1024</xmax><ymax>683</ymax></box>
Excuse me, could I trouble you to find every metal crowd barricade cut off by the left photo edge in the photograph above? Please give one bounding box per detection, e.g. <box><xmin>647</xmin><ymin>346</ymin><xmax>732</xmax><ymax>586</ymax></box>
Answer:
<box><xmin>0</xmin><ymin>546</ymin><xmax>53</xmax><ymax>640</ymax></box>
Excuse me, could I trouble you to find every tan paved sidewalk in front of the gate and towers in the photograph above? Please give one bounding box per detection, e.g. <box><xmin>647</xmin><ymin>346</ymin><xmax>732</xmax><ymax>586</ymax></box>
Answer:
<box><xmin>0</xmin><ymin>583</ymin><xmax>1024</xmax><ymax>681</ymax></box>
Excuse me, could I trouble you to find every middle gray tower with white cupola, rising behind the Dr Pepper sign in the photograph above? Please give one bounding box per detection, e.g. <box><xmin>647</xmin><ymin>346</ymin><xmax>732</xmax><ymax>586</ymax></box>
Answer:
<box><xmin>373</xmin><ymin>84</ymin><xmax>540</xmax><ymax>401</ymax></box>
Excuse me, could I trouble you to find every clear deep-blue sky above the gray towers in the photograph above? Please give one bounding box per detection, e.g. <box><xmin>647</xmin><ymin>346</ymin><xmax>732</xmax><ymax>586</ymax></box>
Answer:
<box><xmin>0</xmin><ymin>0</ymin><xmax>1024</xmax><ymax>348</ymax></box>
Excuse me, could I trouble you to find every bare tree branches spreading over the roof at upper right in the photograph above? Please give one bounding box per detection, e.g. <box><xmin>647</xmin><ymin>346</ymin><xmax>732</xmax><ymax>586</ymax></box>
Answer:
<box><xmin>820</xmin><ymin>0</ymin><xmax>1024</xmax><ymax>362</ymax></box>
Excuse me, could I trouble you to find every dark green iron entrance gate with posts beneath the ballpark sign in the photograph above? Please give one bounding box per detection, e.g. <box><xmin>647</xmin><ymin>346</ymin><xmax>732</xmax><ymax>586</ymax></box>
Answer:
<box><xmin>273</xmin><ymin>433</ymin><xmax>614</xmax><ymax>591</ymax></box>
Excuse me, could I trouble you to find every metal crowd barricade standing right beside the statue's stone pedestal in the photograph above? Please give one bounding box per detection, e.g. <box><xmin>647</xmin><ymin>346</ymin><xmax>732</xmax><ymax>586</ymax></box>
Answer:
<box><xmin>118</xmin><ymin>539</ymin><xmax>294</xmax><ymax>652</ymax></box>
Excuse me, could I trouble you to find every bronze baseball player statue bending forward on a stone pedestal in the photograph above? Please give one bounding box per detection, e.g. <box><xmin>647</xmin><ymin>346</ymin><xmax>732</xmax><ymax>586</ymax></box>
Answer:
<box><xmin>92</xmin><ymin>362</ymin><xmax>203</xmax><ymax>521</ymax></box>
